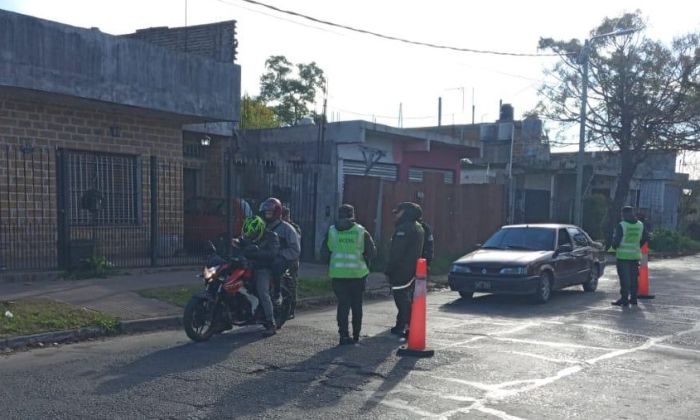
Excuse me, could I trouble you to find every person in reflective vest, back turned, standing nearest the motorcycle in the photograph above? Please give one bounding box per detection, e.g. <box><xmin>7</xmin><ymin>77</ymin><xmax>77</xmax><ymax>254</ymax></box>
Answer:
<box><xmin>321</xmin><ymin>204</ymin><xmax>377</xmax><ymax>345</ymax></box>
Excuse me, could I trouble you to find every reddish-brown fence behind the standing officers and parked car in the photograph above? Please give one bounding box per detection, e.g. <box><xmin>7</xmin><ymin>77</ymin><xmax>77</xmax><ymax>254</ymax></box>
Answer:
<box><xmin>343</xmin><ymin>174</ymin><xmax>505</xmax><ymax>256</ymax></box>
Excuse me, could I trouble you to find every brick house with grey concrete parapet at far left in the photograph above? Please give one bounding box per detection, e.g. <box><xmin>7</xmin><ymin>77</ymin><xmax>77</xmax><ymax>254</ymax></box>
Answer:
<box><xmin>0</xmin><ymin>10</ymin><xmax>241</xmax><ymax>269</ymax></box>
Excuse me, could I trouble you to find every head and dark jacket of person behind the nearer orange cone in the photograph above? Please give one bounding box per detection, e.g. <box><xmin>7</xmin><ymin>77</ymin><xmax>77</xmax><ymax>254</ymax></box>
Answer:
<box><xmin>384</xmin><ymin>205</ymin><xmax>425</xmax><ymax>286</ymax></box>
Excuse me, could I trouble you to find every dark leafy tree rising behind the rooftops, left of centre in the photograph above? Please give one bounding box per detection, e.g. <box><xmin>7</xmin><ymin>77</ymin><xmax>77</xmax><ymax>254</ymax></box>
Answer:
<box><xmin>260</xmin><ymin>55</ymin><xmax>326</xmax><ymax>125</ymax></box>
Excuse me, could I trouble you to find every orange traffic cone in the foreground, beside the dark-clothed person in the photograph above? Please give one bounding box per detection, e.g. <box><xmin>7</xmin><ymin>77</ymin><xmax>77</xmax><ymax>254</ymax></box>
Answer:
<box><xmin>397</xmin><ymin>258</ymin><xmax>435</xmax><ymax>357</ymax></box>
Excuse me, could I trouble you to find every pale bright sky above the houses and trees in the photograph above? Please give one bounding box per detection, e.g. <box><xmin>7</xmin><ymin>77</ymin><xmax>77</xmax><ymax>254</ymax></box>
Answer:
<box><xmin>0</xmin><ymin>0</ymin><xmax>700</xmax><ymax>176</ymax></box>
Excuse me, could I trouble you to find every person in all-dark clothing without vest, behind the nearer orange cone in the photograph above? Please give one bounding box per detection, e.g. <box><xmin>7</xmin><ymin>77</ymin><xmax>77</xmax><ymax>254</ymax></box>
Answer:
<box><xmin>384</xmin><ymin>202</ymin><xmax>425</xmax><ymax>336</ymax></box>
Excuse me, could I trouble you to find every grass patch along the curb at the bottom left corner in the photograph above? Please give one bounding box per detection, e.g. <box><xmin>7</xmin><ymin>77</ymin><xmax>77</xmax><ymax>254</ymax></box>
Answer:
<box><xmin>0</xmin><ymin>299</ymin><xmax>119</xmax><ymax>337</ymax></box>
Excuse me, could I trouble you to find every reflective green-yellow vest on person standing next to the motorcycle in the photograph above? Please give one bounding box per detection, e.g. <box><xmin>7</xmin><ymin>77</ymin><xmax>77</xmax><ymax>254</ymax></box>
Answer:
<box><xmin>328</xmin><ymin>223</ymin><xmax>369</xmax><ymax>279</ymax></box>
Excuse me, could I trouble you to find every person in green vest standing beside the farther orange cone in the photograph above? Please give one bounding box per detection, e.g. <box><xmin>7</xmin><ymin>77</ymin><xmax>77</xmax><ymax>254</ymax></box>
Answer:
<box><xmin>612</xmin><ymin>207</ymin><xmax>649</xmax><ymax>307</ymax></box>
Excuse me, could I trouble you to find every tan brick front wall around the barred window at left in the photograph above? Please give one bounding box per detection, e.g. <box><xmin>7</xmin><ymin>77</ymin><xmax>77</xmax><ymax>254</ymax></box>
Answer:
<box><xmin>0</xmin><ymin>93</ymin><xmax>183</xmax><ymax>269</ymax></box>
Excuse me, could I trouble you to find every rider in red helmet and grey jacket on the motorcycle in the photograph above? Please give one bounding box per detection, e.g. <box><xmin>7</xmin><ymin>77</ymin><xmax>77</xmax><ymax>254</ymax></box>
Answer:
<box><xmin>260</xmin><ymin>197</ymin><xmax>301</xmax><ymax>318</ymax></box>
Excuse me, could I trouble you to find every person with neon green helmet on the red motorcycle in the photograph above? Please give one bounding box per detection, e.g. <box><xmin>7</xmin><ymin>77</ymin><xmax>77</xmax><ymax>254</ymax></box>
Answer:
<box><xmin>234</xmin><ymin>216</ymin><xmax>280</xmax><ymax>336</ymax></box>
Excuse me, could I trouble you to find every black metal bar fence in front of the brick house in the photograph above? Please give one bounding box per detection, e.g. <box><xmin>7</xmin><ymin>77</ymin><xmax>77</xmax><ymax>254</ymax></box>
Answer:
<box><xmin>0</xmin><ymin>145</ymin><xmax>317</xmax><ymax>270</ymax></box>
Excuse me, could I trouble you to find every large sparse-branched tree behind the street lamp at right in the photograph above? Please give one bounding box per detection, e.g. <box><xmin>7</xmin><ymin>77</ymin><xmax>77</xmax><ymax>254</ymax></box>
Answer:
<box><xmin>539</xmin><ymin>11</ymin><xmax>700</xmax><ymax>243</ymax></box>
